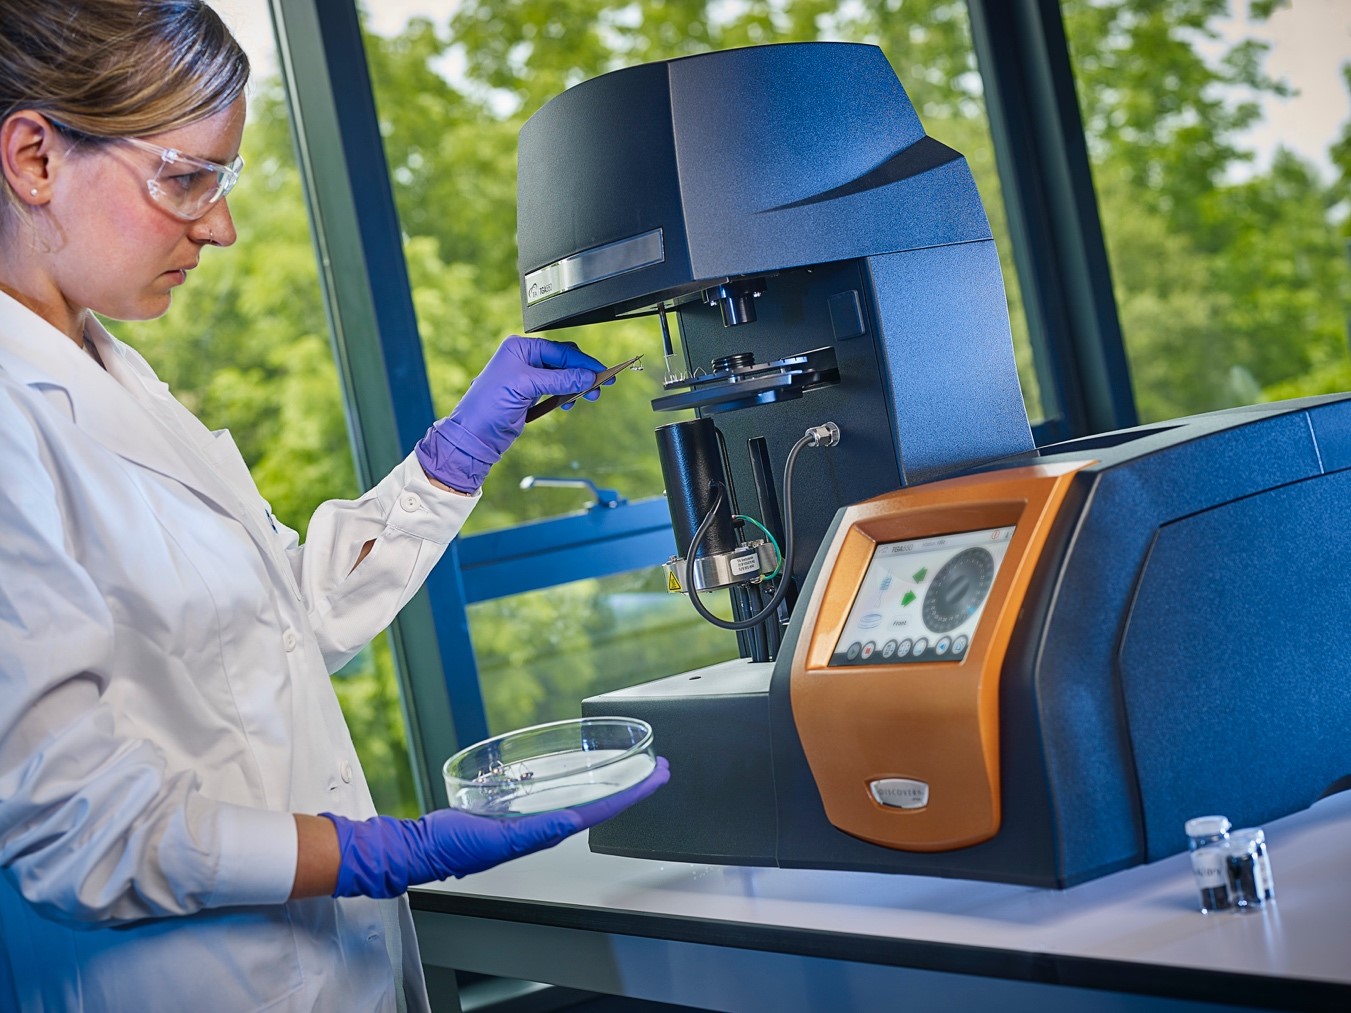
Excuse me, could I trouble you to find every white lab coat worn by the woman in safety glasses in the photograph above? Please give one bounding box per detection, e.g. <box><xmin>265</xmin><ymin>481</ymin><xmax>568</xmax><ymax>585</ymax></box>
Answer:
<box><xmin>0</xmin><ymin>293</ymin><xmax>474</xmax><ymax>1013</ymax></box>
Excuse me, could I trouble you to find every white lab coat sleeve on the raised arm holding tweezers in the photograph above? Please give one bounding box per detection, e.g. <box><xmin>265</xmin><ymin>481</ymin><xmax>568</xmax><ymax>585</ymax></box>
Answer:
<box><xmin>279</xmin><ymin>454</ymin><xmax>478</xmax><ymax>673</ymax></box>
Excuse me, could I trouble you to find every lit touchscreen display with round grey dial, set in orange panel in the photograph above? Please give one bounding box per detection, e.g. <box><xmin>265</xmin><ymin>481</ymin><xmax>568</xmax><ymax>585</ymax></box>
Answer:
<box><xmin>830</xmin><ymin>527</ymin><xmax>1013</xmax><ymax>665</ymax></box>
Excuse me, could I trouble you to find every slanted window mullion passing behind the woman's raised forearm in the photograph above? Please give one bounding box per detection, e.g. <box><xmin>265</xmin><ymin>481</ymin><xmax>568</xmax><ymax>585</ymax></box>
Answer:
<box><xmin>270</xmin><ymin>0</ymin><xmax>488</xmax><ymax>809</ymax></box>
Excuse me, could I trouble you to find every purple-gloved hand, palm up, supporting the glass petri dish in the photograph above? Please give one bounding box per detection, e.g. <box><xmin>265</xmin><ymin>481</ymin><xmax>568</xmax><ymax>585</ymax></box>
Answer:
<box><xmin>320</xmin><ymin>756</ymin><xmax>670</xmax><ymax>897</ymax></box>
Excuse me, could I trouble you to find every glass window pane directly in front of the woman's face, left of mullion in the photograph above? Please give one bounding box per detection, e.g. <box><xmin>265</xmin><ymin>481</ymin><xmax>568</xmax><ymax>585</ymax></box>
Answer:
<box><xmin>109</xmin><ymin>0</ymin><xmax>417</xmax><ymax>814</ymax></box>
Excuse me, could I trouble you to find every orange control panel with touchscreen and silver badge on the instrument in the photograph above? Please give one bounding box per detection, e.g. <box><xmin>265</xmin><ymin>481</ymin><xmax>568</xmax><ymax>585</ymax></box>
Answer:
<box><xmin>790</xmin><ymin>461</ymin><xmax>1092</xmax><ymax>851</ymax></box>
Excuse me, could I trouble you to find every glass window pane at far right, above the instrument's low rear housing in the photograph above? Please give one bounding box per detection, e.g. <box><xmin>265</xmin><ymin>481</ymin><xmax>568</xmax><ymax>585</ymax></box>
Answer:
<box><xmin>1062</xmin><ymin>0</ymin><xmax>1351</xmax><ymax>421</ymax></box>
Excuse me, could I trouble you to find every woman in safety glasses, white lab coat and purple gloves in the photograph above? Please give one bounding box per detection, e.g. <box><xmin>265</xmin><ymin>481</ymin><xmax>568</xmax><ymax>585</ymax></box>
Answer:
<box><xmin>0</xmin><ymin>0</ymin><xmax>666</xmax><ymax>1010</ymax></box>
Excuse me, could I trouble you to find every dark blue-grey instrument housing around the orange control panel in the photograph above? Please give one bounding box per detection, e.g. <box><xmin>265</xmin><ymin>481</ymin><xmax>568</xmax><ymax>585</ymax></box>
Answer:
<box><xmin>517</xmin><ymin>43</ymin><xmax>1351</xmax><ymax>886</ymax></box>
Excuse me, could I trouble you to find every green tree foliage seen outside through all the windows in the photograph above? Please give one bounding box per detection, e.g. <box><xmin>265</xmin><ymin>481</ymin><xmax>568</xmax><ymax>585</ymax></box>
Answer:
<box><xmin>115</xmin><ymin>0</ymin><xmax>1351</xmax><ymax>812</ymax></box>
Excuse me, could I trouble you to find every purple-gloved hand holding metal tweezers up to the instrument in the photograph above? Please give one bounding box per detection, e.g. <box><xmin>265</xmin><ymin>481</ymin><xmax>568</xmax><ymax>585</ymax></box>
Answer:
<box><xmin>417</xmin><ymin>335</ymin><xmax>605</xmax><ymax>493</ymax></box>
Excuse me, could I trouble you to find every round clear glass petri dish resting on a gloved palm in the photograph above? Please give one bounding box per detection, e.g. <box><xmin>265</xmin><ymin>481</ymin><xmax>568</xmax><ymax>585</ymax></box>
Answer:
<box><xmin>442</xmin><ymin>717</ymin><xmax>657</xmax><ymax>816</ymax></box>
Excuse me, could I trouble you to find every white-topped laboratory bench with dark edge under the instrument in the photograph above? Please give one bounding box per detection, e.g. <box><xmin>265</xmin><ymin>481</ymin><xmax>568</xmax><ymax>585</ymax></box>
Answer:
<box><xmin>411</xmin><ymin>791</ymin><xmax>1351</xmax><ymax>1013</ymax></box>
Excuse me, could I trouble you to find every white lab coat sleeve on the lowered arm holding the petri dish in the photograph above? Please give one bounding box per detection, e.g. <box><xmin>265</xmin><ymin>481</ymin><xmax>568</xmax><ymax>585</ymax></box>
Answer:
<box><xmin>0</xmin><ymin>397</ymin><xmax>296</xmax><ymax>923</ymax></box>
